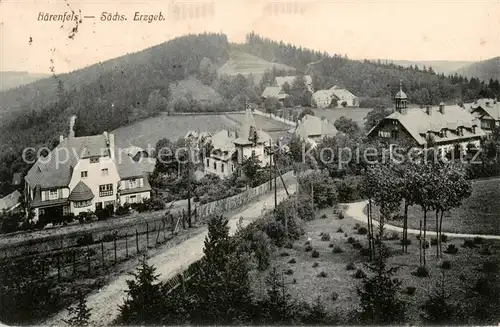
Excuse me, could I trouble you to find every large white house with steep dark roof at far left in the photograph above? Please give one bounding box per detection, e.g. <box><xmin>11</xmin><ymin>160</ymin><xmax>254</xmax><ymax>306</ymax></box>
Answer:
<box><xmin>25</xmin><ymin>116</ymin><xmax>151</xmax><ymax>221</ymax></box>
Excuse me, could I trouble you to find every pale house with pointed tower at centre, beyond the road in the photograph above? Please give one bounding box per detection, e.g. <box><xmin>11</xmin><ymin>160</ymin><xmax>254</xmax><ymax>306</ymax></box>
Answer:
<box><xmin>205</xmin><ymin>105</ymin><xmax>272</xmax><ymax>178</ymax></box>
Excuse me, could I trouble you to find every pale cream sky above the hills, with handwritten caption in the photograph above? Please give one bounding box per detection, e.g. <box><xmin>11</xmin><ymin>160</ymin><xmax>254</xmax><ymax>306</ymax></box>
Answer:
<box><xmin>0</xmin><ymin>0</ymin><xmax>500</xmax><ymax>73</ymax></box>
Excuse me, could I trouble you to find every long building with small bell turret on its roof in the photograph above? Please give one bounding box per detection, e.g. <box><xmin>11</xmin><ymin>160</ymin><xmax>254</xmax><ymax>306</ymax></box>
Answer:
<box><xmin>368</xmin><ymin>84</ymin><xmax>486</xmax><ymax>154</ymax></box>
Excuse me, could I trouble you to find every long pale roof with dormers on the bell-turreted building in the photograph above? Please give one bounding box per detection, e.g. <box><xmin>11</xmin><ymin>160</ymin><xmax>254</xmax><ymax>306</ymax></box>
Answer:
<box><xmin>368</xmin><ymin>105</ymin><xmax>486</xmax><ymax>145</ymax></box>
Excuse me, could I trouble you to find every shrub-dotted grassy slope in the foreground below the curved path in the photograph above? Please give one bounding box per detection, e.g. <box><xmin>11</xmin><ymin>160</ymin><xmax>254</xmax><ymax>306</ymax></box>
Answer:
<box><xmin>252</xmin><ymin>209</ymin><xmax>500</xmax><ymax>324</ymax></box>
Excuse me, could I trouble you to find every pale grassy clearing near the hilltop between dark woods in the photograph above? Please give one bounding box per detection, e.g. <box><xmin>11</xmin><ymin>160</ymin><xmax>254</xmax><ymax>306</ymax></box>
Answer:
<box><xmin>219</xmin><ymin>50</ymin><xmax>295</xmax><ymax>83</ymax></box>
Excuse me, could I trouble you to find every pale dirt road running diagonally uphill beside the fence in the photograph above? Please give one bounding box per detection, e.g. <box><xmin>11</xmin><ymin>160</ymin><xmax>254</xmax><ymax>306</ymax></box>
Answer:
<box><xmin>42</xmin><ymin>183</ymin><xmax>296</xmax><ymax>326</ymax></box>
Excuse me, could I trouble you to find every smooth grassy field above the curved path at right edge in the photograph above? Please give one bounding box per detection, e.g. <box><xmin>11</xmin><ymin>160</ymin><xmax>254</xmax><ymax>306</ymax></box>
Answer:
<box><xmin>374</xmin><ymin>179</ymin><xmax>500</xmax><ymax>235</ymax></box>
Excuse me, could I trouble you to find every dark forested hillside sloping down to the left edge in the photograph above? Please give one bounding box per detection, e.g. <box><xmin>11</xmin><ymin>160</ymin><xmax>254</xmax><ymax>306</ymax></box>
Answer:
<box><xmin>0</xmin><ymin>34</ymin><xmax>229</xmax><ymax>194</ymax></box>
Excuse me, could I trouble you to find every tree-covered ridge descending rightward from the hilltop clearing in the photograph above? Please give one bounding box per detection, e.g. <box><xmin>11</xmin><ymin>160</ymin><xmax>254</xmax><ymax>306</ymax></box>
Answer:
<box><xmin>246</xmin><ymin>33</ymin><xmax>500</xmax><ymax>104</ymax></box>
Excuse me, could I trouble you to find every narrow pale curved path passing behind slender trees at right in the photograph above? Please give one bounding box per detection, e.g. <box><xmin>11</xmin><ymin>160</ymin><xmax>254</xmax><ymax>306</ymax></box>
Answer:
<box><xmin>345</xmin><ymin>200</ymin><xmax>500</xmax><ymax>240</ymax></box>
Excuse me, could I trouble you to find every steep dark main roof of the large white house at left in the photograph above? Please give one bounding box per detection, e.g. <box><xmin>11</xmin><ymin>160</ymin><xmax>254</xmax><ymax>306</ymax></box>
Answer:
<box><xmin>25</xmin><ymin>134</ymin><xmax>109</xmax><ymax>189</ymax></box>
